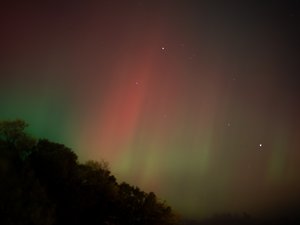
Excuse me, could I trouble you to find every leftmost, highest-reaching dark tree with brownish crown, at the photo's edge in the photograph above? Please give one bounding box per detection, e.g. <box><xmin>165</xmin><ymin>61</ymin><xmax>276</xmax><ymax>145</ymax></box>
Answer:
<box><xmin>0</xmin><ymin>120</ymin><xmax>55</xmax><ymax>225</ymax></box>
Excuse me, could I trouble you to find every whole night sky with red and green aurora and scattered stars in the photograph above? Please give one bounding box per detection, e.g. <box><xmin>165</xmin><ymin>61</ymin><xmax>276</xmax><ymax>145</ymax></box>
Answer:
<box><xmin>0</xmin><ymin>0</ymin><xmax>300</xmax><ymax>218</ymax></box>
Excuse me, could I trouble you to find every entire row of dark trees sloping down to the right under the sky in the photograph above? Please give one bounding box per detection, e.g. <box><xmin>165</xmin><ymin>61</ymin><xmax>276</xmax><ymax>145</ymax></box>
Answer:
<box><xmin>0</xmin><ymin>120</ymin><xmax>178</xmax><ymax>225</ymax></box>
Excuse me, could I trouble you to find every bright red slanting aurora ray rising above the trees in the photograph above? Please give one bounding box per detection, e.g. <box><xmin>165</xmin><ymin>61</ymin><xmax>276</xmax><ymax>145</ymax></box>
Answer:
<box><xmin>79</xmin><ymin>29</ymin><xmax>163</xmax><ymax>164</ymax></box>
